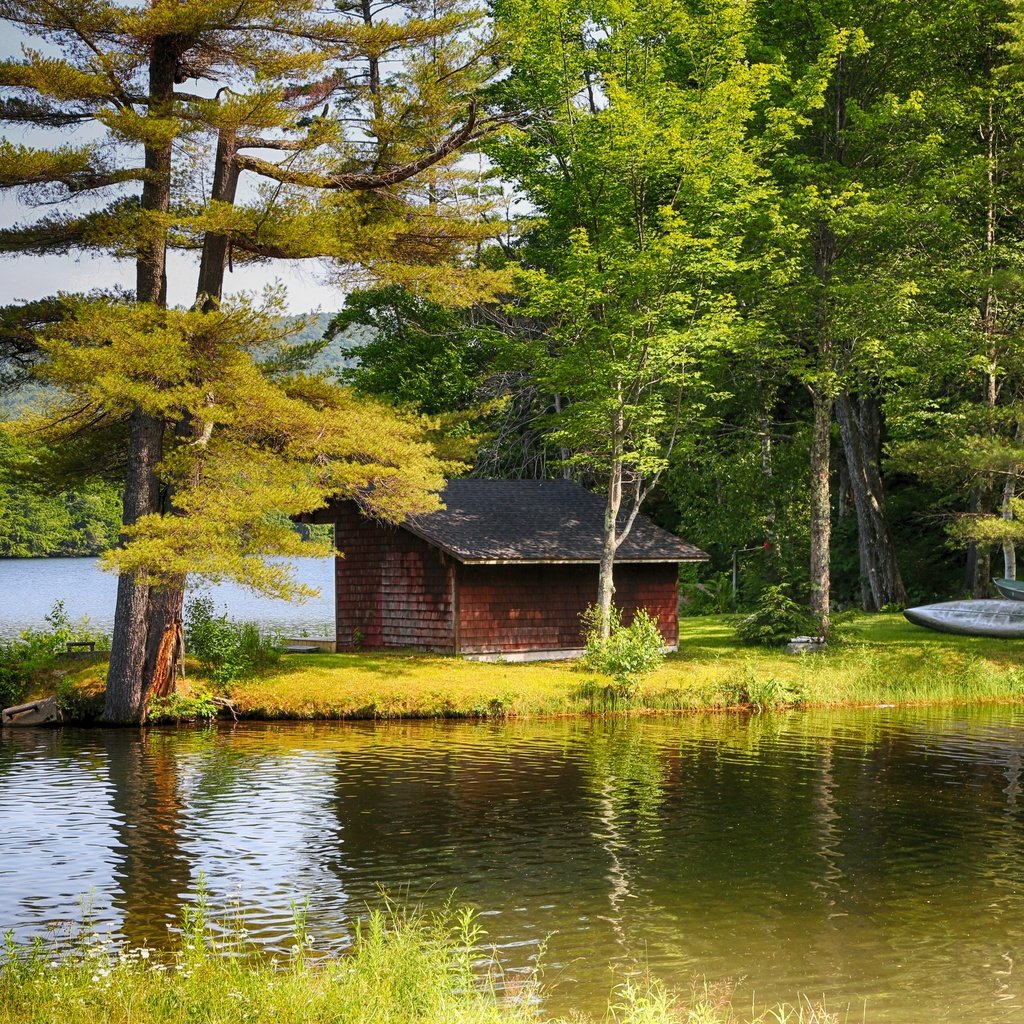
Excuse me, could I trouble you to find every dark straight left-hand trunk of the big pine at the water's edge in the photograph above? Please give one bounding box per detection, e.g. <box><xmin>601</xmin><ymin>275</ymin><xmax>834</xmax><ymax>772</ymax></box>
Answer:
<box><xmin>103</xmin><ymin>36</ymin><xmax>181</xmax><ymax>723</ymax></box>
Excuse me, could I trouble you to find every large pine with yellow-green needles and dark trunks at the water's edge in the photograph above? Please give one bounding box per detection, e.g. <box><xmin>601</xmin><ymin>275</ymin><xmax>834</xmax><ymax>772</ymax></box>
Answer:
<box><xmin>0</xmin><ymin>0</ymin><xmax>505</xmax><ymax>721</ymax></box>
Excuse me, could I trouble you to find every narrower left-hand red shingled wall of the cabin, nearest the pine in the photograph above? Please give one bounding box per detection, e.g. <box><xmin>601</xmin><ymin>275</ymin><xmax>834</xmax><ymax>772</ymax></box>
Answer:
<box><xmin>327</xmin><ymin>503</ymin><xmax>455</xmax><ymax>651</ymax></box>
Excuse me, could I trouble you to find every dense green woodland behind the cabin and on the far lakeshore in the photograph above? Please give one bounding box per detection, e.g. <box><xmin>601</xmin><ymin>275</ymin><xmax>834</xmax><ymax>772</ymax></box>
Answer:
<box><xmin>0</xmin><ymin>0</ymin><xmax>1024</xmax><ymax>611</ymax></box>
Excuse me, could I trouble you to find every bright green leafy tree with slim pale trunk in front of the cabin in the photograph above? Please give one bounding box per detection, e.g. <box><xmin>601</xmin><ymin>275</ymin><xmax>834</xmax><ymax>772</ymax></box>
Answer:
<box><xmin>490</xmin><ymin>0</ymin><xmax>772</xmax><ymax>636</ymax></box>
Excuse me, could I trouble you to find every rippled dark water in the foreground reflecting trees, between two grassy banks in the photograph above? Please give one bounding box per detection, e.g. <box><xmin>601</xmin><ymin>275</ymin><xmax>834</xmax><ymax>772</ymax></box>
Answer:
<box><xmin>0</xmin><ymin>708</ymin><xmax>1024</xmax><ymax>1024</ymax></box>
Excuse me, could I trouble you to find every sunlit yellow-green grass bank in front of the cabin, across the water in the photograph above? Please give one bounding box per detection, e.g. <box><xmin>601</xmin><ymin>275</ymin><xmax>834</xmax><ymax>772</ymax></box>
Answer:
<box><xmin>54</xmin><ymin>614</ymin><xmax>1024</xmax><ymax>720</ymax></box>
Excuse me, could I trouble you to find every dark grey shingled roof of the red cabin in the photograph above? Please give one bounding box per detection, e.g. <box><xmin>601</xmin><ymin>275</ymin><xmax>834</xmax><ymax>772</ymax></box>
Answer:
<box><xmin>403</xmin><ymin>480</ymin><xmax>708</xmax><ymax>562</ymax></box>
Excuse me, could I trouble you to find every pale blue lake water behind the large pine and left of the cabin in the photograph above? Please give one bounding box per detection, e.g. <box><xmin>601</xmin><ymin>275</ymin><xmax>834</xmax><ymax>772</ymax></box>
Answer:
<box><xmin>0</xmin><ymin>558</ymin><xmax>334</xmax><ymax>639</ymax></box>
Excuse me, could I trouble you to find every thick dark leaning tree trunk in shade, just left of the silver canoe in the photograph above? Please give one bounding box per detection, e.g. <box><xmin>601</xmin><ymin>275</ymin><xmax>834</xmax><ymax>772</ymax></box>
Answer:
<box><xmin>836</xmin><ymin>394</ymin><xmax>906</xmax><ymax>611</ymax></box>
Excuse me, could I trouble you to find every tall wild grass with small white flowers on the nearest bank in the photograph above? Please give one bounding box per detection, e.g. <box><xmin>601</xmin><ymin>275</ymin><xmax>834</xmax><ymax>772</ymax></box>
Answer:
<box><xmin>0</xmin><ymin>900</ymin><xmax>840</xmax><ymax>1024</ymax></box>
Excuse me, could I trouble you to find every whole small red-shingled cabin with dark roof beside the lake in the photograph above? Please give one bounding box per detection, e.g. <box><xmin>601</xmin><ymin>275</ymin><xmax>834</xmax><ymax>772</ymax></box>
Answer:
<box><xmin>312</xmin><ymin>479</ymin><xmax>708</xmax><ymax>660</ymax></box>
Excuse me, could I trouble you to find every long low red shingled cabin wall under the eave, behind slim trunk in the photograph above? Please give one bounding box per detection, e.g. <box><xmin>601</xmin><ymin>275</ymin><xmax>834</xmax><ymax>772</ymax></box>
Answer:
<box><xmin>456</xmin><ymin>563</ymin><xmax>679</xmax><ymax>654</ymax></box>
